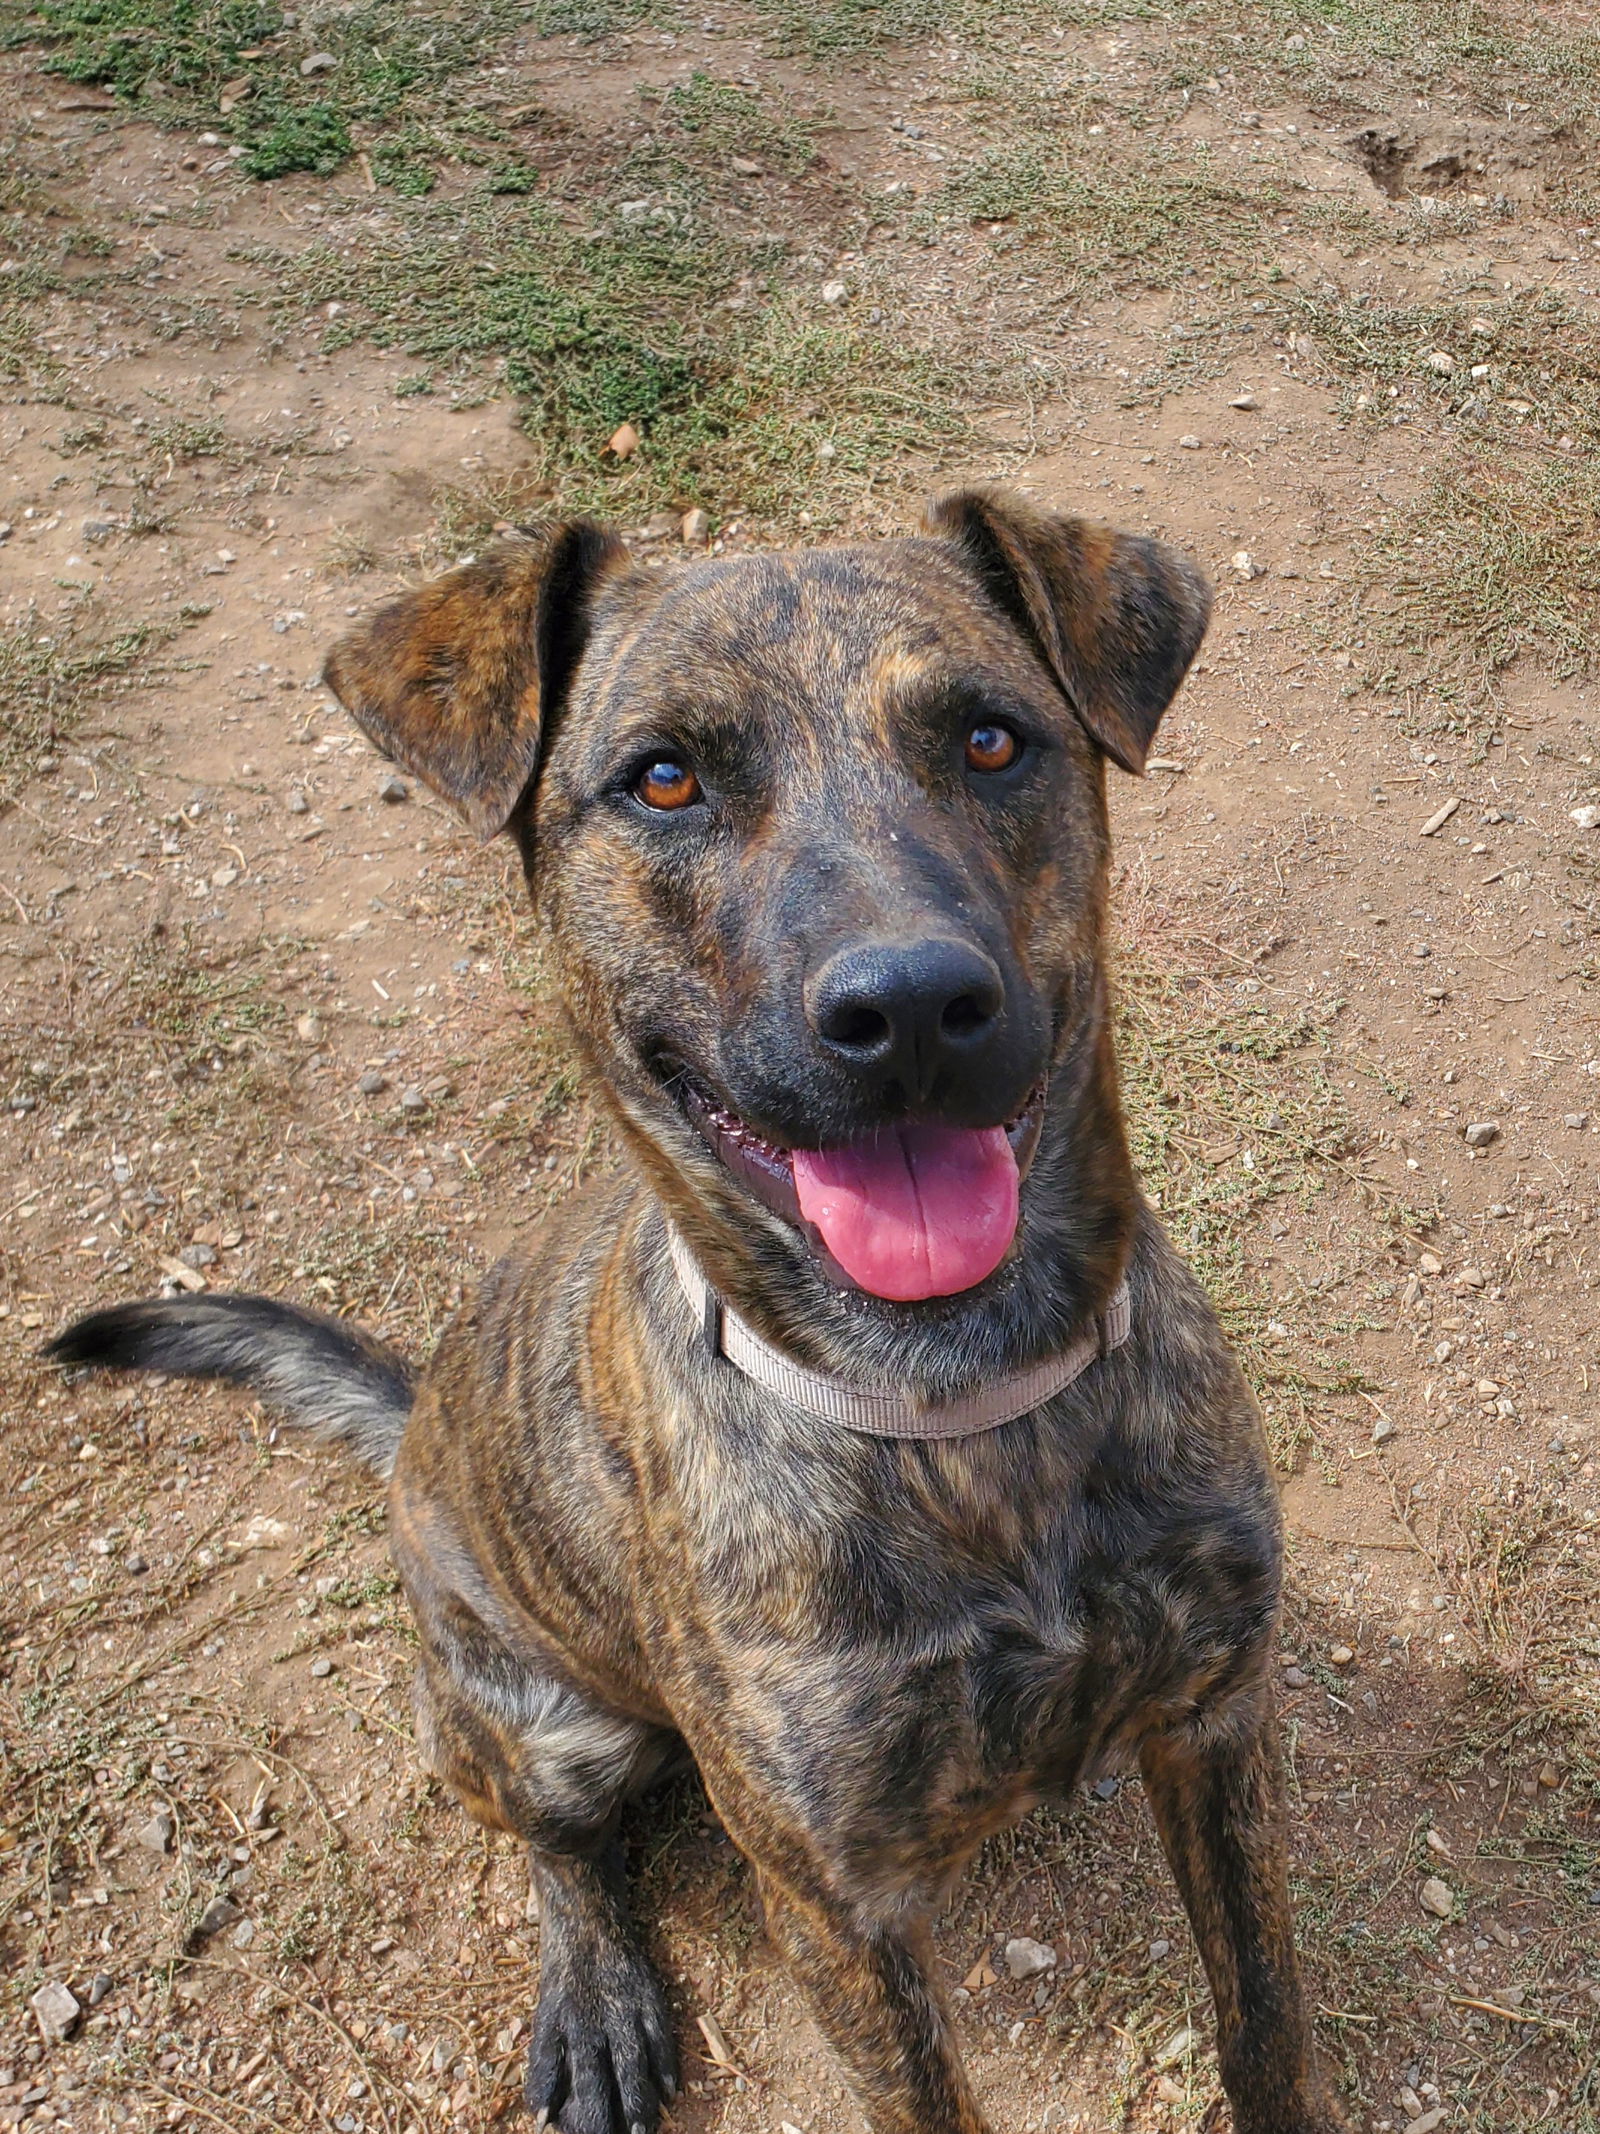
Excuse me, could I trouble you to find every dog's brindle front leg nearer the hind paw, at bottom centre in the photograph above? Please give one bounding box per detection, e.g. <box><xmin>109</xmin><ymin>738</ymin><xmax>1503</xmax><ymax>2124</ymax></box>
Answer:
<box><xmin>747</xmin><ymin>1848</ymin><xmax>988</xmax><ymax>2134</ymax></box>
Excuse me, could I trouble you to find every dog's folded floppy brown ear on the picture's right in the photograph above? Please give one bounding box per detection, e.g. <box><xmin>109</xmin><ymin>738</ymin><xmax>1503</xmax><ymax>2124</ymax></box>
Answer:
<box><xmin>926</xmin><ymin>489</ymin><xmax>1212</xmax><ymax>773</ymax></box>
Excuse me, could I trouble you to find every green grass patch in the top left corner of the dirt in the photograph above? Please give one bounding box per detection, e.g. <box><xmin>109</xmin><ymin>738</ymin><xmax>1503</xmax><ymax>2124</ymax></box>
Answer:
<box><xmin>11</xmin><ymin>0</ymin><xmax>527</xmax><ymax>190</ymax></box>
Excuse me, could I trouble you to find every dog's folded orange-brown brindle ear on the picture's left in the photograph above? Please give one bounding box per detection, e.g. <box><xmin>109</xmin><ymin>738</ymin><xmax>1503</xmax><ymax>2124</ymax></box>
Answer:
<box><xmin>322</xmin><ymin>519</ymin><xmax>627</xmax><ymax>839</ymax></box>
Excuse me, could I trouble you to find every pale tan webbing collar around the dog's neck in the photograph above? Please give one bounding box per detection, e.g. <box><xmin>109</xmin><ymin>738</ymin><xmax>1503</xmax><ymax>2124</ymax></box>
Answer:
<box><xmin>668</xmin><ymin>1223</ymin><xmax>1131</xmax><ymax>1438</ymax></box>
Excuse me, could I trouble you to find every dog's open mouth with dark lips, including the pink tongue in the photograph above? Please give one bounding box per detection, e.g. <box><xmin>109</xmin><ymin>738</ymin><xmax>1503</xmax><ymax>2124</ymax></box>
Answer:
<box><xmin>681</xmin><ymin>1078</ymin><xmax>1045</xmax><ymax>1304</ymax></box>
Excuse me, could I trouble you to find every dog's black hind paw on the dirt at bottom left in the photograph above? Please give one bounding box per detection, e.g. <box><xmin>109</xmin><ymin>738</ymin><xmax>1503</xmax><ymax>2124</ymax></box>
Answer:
<box><xmin>525</xmin><ymin>1955</ymin><xmax>678</xmax><ymax>2134</ymax></box>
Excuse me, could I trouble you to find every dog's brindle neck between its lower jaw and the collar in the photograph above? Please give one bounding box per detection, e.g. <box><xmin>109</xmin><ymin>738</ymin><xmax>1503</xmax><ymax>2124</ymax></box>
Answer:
<box><xmin>651</xmin><ymin>967</ymin><xmax>1141</xmax><ymax>1402</ymax></box>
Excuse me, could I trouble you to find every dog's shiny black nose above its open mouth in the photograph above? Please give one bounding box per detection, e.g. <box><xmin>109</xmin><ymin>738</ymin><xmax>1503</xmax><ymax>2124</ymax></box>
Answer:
<box><xmin>806</xmin><ymin>937</ymin><xmax>1005</xmax><ymax>1103</ymax></box>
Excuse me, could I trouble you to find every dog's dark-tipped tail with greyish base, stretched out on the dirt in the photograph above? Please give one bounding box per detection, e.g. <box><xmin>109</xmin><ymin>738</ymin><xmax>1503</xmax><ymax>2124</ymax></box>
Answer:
<box><xmin>45</xmin><ymin>1295</ymin><xmax>416</xmax><ymax>1475</ymax></box>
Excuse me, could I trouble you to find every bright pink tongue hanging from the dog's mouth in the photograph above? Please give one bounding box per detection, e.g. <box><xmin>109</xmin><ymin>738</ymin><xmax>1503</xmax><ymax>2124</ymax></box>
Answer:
<box><xmin>794</xmin><ymin>1127</ymin><xmax>1018</xmax><ymax>1304</ymax></box>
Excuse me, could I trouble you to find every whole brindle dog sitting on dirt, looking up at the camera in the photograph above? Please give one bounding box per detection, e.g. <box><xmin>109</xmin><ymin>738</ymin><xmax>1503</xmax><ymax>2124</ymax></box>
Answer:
<box><xmin>53</xmin><ymin>491</ymin><xmax>1342</xmax><ymax>2134</ymax></box>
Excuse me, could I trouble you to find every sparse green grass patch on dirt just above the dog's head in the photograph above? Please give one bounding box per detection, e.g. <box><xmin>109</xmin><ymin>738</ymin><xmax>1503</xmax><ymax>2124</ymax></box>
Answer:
<box><xmin>288</xmin><ymin>170</ymin><xmax>969</xmax><ymax>525</ymax></box>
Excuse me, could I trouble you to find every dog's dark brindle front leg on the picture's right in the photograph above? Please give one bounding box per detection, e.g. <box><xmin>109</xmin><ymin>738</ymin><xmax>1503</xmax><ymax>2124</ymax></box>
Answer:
<box><xmin>1139</xmin><ymin>1690</ymin><xmax>1344</xmax><ymax>2134</ymax></box>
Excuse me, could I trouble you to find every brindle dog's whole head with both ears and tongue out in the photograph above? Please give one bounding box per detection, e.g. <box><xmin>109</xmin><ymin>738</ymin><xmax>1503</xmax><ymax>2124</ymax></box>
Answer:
<box><xmin>329</xmin><ymin>491</ymin><xmax>1207</xmax><ymax>1374</ymax></box>
